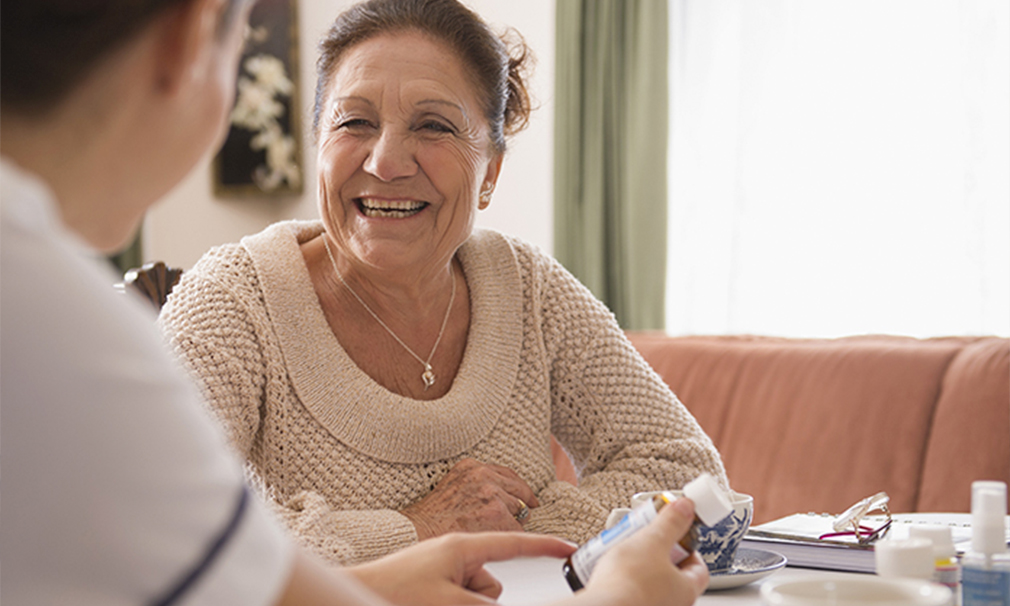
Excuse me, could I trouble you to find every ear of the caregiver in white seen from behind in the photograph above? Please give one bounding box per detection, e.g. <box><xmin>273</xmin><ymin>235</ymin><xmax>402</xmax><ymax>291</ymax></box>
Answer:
<box><xmin>155</xmin><ymin>0</ymin><xmax>226</xmax><ymax>96</ymax></box>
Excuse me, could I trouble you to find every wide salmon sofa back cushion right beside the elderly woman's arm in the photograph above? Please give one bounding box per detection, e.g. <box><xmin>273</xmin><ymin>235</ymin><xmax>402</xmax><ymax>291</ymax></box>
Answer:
<box><xmin>629</xmin><ymin>333</ymin><xmax>973</xmax><ymax>523</ymax></box>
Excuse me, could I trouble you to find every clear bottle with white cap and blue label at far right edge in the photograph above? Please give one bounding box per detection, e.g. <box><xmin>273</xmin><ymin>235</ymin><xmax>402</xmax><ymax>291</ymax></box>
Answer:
<box><xmin>961</xmin><ymin>482</ymin><xmax>1010</xmax><ymax>606</ymax></box>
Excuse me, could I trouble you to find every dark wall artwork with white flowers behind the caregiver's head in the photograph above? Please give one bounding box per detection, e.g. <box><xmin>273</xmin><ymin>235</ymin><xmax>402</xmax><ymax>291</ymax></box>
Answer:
<box><xmin>213</xmin><ymin>0</ymin><xmax>303</xmax><ymax>197</ymax></box>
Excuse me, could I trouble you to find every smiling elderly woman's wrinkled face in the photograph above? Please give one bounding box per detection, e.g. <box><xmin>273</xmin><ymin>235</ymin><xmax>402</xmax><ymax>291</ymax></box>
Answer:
<box><xmin>318</xmin><ymin>31</ymin><xmax>501</xmax><ymax>275</ymax></box>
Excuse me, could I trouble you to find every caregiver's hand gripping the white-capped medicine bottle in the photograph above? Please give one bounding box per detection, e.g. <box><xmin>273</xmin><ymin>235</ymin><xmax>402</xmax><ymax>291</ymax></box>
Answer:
<box><xmin>573</xmin><ymin>499</ymin><xmax>708</xmax><ymax>606</ymax></box>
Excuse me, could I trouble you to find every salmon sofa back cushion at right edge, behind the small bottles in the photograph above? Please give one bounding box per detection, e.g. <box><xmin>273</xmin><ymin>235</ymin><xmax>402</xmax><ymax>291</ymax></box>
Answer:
<box><xmin>916</xmin><ymin>337</ymin><xmax>1010</xmax><ymax>512</ymax></box>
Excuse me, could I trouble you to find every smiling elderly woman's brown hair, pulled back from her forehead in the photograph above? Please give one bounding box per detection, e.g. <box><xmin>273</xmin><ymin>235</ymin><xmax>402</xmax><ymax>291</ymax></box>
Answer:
<box><xmin>312</xmin><ymin>0</ymin><xmax>532</xmax><ymax>152</ymax></box>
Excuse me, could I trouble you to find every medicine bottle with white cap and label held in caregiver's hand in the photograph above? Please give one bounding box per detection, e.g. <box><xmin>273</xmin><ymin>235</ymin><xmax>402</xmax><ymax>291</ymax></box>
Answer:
<box><xmin>562</xmin><ymin>474</ymin><xmax>733</xmax><ymax>591</ymax></box>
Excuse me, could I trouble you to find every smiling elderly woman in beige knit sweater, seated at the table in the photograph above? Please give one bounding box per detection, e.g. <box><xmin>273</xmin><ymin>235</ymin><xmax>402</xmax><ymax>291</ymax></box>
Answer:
<box><xmin>162</xmin><ymin>0</ymin><xmax>725</xmax><ymax>564</ymax></box>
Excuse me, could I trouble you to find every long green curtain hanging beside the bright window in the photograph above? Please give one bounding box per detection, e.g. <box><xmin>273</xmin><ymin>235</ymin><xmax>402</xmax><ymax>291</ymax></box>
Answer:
<box><xmin>554</xmin><ymin>0</ymin><xmax>668</xmax><ymax>329</ymax></box>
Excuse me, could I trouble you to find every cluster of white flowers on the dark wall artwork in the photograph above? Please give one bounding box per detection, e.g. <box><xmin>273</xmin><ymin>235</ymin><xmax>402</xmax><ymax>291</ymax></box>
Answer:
<box><xmin>231</xmin><ymin>55</ymin><xmax>301</xmax><ymax>191</ymax></box>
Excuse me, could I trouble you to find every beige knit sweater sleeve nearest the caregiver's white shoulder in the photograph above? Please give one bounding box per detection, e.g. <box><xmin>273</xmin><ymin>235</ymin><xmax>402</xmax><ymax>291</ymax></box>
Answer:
<box><xmin>159</xmin><ymin>243</ymin><xmax>417</xmax><ymax>565</ymax></box>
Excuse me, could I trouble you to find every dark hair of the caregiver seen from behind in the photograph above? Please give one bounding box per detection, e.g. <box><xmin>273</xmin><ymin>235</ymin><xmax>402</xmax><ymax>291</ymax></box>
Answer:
<box><xmin>0</xmin><ymin>0</ymin><xmax>248</xmax><ymax>115</ymax></box>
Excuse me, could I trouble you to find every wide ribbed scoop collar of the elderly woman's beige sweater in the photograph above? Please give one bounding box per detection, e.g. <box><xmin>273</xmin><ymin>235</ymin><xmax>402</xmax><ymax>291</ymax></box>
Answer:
<box><xmin>241</xmin><ymin>221</ymin><xmax>523</xmax><ymax>464</ymax></box>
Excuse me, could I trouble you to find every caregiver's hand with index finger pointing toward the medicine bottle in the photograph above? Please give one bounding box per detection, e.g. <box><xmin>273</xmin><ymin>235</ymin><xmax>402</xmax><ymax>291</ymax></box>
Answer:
<box><xmin>344</xmin><ymin>532</ymin><xmax>575</xmax><ymax>606</ymax></box>
